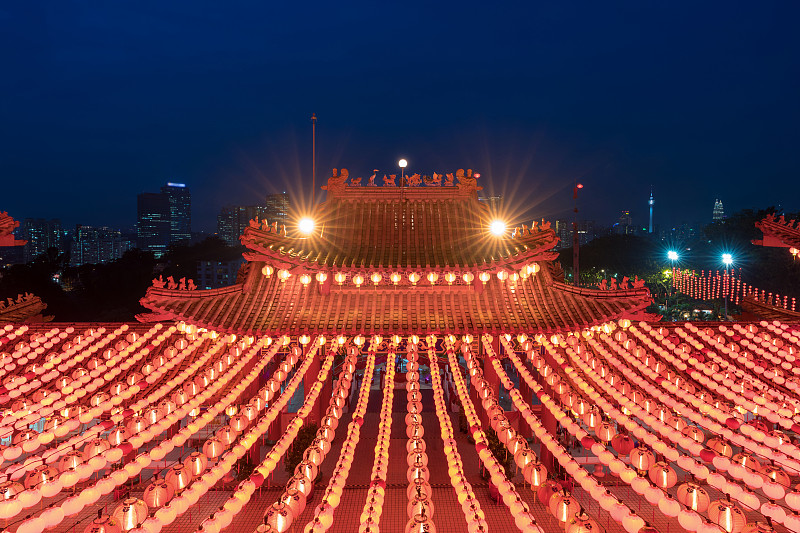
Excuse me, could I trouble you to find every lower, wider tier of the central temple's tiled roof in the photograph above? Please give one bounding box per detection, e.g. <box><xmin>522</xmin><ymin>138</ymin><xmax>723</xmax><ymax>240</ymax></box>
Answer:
<box><xmin>141</xmin><ymin>263</ymin><xmax>651</xmax><ymax>334</ymax></box>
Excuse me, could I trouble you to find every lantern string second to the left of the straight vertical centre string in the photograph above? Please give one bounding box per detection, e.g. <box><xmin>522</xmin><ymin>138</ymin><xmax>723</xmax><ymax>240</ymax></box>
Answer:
<box><xmin>304</xmin><ymin>339</ymin><xmax>379</xmax><ymax>533</ymax></box>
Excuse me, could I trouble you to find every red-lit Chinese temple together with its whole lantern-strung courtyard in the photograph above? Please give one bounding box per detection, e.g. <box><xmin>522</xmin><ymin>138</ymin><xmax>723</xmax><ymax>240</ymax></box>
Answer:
<box><xmin>0</xmin><ymin>175</ymin><xmax>800</xmax><ymax>533</ymax></box>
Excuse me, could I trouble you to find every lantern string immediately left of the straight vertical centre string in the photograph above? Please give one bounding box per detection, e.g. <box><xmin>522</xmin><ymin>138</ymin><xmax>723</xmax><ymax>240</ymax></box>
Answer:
<box><xmin>358</xmin><ymin>345</ymin><xmax>396</xmax><ymax>533</ymax></box>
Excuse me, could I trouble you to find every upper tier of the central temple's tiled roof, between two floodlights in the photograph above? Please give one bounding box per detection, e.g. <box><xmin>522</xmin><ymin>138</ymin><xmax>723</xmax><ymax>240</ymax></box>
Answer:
<box><xmin>241</xmin><ymin>181</ymin><xmax>558</xmax><ymax>271</ymax></box>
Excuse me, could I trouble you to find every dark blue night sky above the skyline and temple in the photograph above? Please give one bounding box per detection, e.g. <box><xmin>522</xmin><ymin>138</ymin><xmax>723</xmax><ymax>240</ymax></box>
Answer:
<box><xmin>0</xmin><ymin>0</ymin><xmax>800</xmax><ymax>230</ymax></box>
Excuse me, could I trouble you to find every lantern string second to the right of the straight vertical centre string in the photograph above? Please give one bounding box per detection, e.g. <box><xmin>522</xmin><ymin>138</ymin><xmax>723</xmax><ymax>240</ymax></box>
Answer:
<box><xmin>446</xmin><ymin>339</ymin><xmax>543</xmax><ymax>533</ymax></box>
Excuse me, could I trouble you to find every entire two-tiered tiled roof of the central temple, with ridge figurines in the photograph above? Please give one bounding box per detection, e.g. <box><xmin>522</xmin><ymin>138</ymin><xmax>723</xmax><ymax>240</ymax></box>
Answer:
<box><xmin>137</xmin><ymin>175</ymin><xmax>652</xmax><ymax>334</ymax></box>
